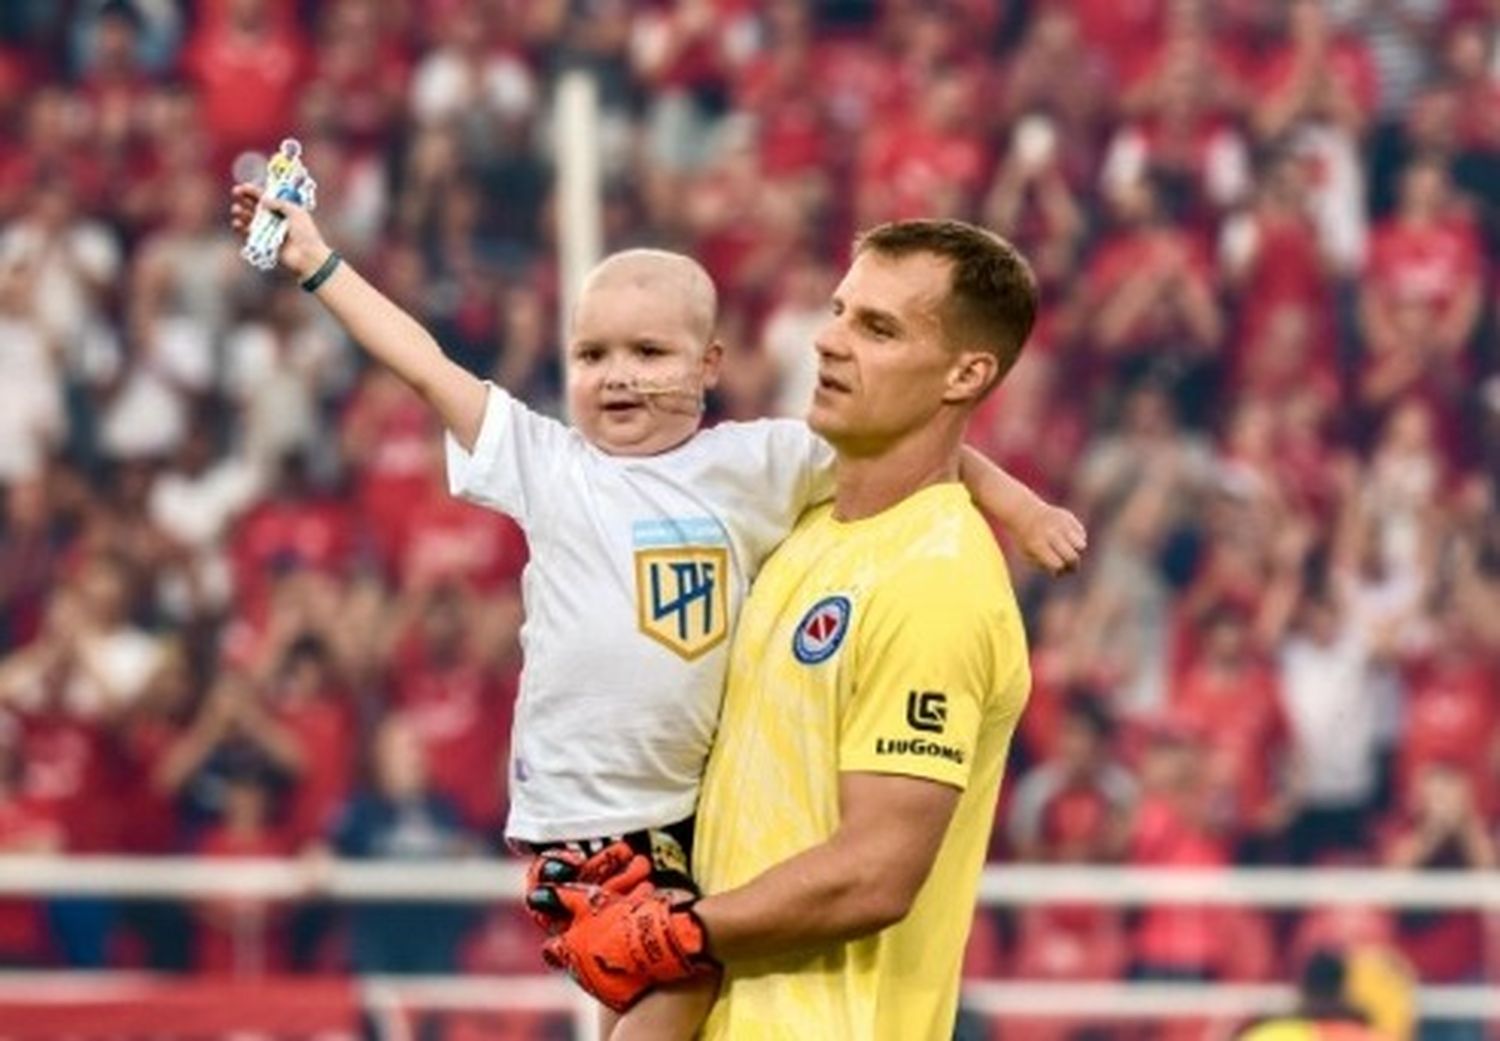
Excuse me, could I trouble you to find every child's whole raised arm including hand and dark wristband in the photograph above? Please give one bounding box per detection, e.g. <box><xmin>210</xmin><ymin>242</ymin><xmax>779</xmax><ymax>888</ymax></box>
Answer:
<box><xmin>230</xmin><ymin>185</ymin><xmax>486</xmax><ymax>452</ymax></box>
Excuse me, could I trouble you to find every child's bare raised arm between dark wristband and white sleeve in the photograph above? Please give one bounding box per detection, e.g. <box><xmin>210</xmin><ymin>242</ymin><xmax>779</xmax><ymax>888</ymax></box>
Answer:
<box><xmin>299</xmin><ymin>261</ymin><xmax>485</xmax><ymax>450</ymax></box>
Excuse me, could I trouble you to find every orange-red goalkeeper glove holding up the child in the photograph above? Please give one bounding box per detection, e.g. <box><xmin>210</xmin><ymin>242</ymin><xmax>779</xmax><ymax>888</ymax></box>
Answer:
<box><xmin>542</xmin><ymin>885</ymin><xmax>714</xmax><ymax>1013</ymax></box>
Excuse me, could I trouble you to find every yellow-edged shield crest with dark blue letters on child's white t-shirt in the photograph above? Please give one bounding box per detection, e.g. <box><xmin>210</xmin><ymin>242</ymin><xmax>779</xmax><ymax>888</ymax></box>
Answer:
<box><xmin>636</xmin><ymin>546</ymin><xmax>729</xmax><ymax>662</ymax></box>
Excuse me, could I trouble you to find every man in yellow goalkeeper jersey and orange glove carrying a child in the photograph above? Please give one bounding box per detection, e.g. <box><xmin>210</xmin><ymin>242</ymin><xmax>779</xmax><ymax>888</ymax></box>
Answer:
<box><xmin>549</xmin><ymin>221</ymin><xmax>1037</xmax><ymax>1041</ymax></box>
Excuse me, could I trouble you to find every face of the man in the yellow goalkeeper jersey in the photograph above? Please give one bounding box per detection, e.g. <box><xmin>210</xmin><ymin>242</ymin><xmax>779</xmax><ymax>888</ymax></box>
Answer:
<box><xmin>807</xmin><ymin>251</ymin><xmax>959</xmax><ymax>455</ymax></box>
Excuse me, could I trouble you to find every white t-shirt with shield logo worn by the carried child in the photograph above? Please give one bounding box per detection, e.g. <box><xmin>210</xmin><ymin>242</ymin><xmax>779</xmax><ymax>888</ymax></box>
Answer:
<box><xmin>447</xmin><ymin>387</ymin><xmax>833</xmax><ymax>842</ymax></box>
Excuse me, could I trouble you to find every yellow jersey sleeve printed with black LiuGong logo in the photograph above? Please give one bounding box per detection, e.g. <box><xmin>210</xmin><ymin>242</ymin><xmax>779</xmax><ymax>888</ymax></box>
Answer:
<box><xmin>839</xmin><ymin>560</ymin><xmax>1004</xmax><ymax>791</ymax></box>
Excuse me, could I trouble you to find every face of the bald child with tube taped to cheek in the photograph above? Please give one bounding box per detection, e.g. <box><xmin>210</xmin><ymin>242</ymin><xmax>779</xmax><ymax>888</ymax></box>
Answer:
<box><xmin>567</xmin><ymin>284</ymin><xmax>723</xmax><ymax>456</ymax></box>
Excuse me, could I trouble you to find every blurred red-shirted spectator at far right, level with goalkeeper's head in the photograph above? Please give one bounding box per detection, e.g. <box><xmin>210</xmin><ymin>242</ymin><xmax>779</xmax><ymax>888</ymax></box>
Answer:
<box><xmin>1359</xmin><ymin>159</ymin><xmax>1484</xmax><ymax>429</ymax></box>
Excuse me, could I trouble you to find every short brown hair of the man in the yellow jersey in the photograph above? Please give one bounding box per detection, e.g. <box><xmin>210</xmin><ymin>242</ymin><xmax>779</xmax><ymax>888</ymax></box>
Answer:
<box><xmin>855</xmin><ymin>221</ymin><xmax>1038</xmax><ymax>384</ymax></box>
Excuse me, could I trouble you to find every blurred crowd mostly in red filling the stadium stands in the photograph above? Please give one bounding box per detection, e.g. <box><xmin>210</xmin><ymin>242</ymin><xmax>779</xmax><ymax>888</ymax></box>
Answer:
<box><xmin>0</xmin><ymin>0</ymin><xmax>1500</xmax><ymax>1038</ymax></box>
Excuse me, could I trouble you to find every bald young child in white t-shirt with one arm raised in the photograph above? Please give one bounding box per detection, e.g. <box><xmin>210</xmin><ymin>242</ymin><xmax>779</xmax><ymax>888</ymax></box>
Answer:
<box><xmin>233</xmin><ymin>185</ymin><xmax>1083</xmax><ymax>1041</ymax></box>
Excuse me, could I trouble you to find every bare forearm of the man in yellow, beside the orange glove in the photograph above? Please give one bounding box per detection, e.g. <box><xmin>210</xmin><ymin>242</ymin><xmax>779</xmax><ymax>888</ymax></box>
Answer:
<box><xmin>695</xmin><ymin>843</ymin><xmax>908</xmax><ymax>962</ymax></box>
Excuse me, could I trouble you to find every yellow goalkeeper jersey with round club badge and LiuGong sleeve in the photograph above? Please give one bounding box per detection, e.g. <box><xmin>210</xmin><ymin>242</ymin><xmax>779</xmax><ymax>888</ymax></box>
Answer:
<box><xmin>695</xmin><ymin>483</ymin><xmax>1031</xmax><ymax>1041</ymax></box>
